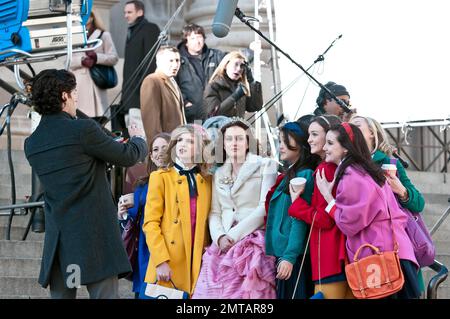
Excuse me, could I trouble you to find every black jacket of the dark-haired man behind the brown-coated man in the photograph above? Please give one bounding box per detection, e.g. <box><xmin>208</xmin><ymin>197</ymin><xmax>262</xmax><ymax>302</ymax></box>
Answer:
<box><xmin>176</xmin><ymin>42</ymin><xmax>226</xmax><ymax>123</ymax></box>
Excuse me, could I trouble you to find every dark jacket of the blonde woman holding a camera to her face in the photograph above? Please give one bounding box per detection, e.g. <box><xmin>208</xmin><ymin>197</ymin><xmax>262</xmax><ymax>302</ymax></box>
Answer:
<box><xmin>203</xmin><ymin>76</ymin><xmax>263</xmax><ymax>118</ymax></box>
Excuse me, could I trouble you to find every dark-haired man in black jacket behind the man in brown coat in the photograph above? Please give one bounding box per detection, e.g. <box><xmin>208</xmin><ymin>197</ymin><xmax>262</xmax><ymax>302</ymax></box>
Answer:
<box><xmin>176</xmin><ymin>23</ymin><xmax>225</xmax><ymax>123</ymax></box>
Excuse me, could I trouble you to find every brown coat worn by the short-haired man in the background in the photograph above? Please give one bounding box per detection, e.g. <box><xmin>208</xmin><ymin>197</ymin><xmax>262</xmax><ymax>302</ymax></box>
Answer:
<box><xmin>141</xmin><ymin>70</ymin><xmax>186</xmax><ymax>141</ymax></box>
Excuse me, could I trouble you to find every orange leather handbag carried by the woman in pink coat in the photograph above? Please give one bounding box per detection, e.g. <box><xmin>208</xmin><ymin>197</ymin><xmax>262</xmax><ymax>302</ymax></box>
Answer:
<box><xmin>345</xmin><ymin>209</ymin><xmax>405</xmax><ymax>299</ymax></box>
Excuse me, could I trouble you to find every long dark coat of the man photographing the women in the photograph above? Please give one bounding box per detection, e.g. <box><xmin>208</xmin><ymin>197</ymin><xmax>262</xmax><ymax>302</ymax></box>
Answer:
<box><xmin>24</xmin><ymin>112</ymin><xmax>148</xmax><ymax>288</ymax></box>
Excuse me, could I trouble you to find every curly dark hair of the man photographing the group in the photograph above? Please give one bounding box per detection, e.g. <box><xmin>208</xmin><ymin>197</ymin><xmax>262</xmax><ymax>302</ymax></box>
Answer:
<box><xmin>29</xmin><ymin>69</ymin><xmax>77</xmax><ymax>115</ymax></box>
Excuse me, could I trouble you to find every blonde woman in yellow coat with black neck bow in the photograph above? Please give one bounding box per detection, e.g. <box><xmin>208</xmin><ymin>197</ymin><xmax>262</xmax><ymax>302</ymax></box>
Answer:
<box><xmin>143</xmin><ymin>125</ymin><xmax>211</xmax><ymax>294</ymax></box>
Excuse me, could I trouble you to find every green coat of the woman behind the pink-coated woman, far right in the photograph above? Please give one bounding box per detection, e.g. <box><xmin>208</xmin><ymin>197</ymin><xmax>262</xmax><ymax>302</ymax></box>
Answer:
<box><xmin>372</xmin><ymin>151</ymin><xmax>425</xmax><ymax>213</ymax></box>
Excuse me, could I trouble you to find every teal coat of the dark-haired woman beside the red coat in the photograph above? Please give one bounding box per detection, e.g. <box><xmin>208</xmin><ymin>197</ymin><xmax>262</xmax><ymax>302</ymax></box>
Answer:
<box><xmin>266</xmin><ymin>169</ymin><xmax>314</xmax><ymax>264</ymax></box>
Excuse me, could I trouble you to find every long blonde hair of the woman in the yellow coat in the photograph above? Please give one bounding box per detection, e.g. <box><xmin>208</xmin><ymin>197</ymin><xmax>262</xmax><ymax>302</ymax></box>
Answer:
<box><xmin>164</xmin><ymin>124</ymin><xmax>214</xmax><ymax>177</ymax></box>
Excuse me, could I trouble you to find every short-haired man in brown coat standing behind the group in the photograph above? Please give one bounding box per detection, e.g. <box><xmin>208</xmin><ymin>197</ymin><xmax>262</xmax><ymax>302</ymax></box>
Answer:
<box><xmin>141</xmin><ymin>46</ymin><xmax>186</xmax><ymax>143</ymax></box>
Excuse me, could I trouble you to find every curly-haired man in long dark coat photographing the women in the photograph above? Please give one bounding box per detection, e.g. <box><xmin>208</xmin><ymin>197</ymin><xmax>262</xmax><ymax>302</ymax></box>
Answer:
<box><xmin>24</xmin><ymin>69</ymin><xmax>148</xmax><ymax>298</ymax></box>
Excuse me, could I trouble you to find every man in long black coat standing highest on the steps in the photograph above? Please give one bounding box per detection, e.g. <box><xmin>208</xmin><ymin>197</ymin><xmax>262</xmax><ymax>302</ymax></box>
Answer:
<box><xmin>112</xmin><ymin>0</ymin><xmax>161</xmax><ymax>131</ymax></box>
